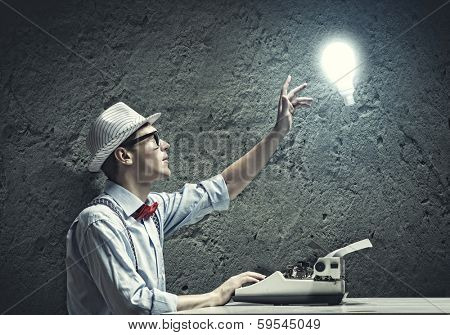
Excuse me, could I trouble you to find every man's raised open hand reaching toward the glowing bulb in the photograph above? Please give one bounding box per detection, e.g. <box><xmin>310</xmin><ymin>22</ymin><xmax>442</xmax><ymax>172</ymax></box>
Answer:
<box><xmin>274</xmin><ymin>75</ymin><xmax>313</xmax><ymax>135</ymax></box>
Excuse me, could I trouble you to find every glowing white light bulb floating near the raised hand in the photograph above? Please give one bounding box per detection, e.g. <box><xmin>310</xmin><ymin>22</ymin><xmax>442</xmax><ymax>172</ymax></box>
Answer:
<box><xmin>321</xmin><ymin>41</ymin><xmax>356</xmax><ymax>106</ymax></box>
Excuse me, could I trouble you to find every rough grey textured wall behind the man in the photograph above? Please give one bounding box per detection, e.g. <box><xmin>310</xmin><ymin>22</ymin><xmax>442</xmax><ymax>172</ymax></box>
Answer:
<box><xmin>0</xmin><ymin>0</ymin><xmax>450</xmax><ymax>314</ymax></box>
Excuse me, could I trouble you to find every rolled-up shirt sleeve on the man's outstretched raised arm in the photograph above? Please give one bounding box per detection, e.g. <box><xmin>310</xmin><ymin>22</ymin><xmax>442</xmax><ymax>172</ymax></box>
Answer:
<box><xmin>149</xmin><ymin>174</ymin><xmax>230</xmax><ymax>236</ymax></box>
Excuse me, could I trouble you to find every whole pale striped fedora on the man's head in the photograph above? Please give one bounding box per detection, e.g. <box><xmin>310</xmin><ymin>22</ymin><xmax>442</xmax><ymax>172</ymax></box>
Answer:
<box><xmin>87</xmin><ymin>102</ymin><xmax>161</xmax><ymax>172</ymax></box>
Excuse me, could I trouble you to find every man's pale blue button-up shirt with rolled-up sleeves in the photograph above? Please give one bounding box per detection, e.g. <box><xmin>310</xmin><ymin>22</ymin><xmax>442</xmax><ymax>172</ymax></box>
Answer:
<box><xmin>66</xmin><ymin>174</ymin><xmax>230</xmax><ymax>314</ymax></box>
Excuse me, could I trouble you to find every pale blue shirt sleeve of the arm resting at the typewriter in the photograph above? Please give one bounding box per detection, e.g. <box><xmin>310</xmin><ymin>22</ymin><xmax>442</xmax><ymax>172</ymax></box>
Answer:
<box><xmin>80</xmin><ymin>220</ymin><xmax>178</xmax><ymax>314</ymax></box>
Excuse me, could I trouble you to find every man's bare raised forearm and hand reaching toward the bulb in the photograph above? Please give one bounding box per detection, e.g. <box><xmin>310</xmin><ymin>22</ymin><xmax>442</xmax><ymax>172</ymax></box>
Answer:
<box><xmin>222</xmin><ymin>75</ymin><xmax>312</xmax><ymax>200</ymax></box>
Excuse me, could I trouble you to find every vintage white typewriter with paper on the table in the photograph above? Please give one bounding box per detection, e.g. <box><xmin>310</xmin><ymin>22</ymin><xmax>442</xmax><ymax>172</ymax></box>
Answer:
<box><xmin>233</xmin><ymin>239</ymin><xmax>372</xmax><ymax>305</ymax></box>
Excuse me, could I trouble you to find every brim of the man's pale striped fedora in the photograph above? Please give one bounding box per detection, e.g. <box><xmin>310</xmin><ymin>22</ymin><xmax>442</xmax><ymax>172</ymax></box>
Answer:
<box><xmin>88</xmin><ymin>113</ymin><xmax>161</xmax><ymax>172</ymax></box>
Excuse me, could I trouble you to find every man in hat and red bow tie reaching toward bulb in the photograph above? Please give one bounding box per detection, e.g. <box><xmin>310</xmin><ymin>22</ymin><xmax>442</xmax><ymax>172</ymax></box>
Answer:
<box><xmin>66</xmin><ymin>76</ymin><xmax>312</xmax><ymax>314</ymax></box>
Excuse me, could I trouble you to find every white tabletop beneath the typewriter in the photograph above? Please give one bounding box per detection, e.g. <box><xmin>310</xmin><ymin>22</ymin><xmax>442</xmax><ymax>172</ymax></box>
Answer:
<box><xmin>171</xmin><ymin>298</ymin><xmax>450</xmax><ymax>314</ymax></box>
